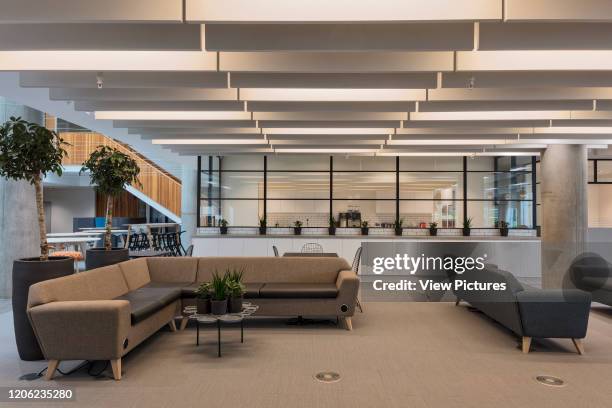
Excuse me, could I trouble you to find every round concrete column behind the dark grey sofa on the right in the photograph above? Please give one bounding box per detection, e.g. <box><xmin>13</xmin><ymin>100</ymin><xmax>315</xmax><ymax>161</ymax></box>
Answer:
<box><xmin>540</xmin><ymin>145</ymin><xmax>588</xmax><ymax>288</ymax></box>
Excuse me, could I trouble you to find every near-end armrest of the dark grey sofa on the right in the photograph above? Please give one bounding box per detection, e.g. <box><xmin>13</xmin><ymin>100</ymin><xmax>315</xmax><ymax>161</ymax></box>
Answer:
<box><xmin>516</xmin><ymin>289</ymin><xmax>591</xmax><ymax>339</ymax></box>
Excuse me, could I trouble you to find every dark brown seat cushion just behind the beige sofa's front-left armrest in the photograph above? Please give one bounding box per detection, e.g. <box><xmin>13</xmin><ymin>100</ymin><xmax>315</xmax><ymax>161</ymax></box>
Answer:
<box><xmin>115</xmin><ymin>285</ymin><xmax>181</xmax><ymax>325</ymax></box>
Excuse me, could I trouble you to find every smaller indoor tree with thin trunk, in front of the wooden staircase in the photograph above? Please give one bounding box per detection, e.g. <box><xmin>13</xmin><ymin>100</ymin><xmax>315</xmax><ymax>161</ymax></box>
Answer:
<box><xmin>81</xmin><ymin>146</ymin><xmax>140</xmax><ymax>251</ymax></box>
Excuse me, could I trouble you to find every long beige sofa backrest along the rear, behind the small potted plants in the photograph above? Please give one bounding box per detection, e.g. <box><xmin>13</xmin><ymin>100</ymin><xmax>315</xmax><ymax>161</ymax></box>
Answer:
<box><xmin>197</xmin><ymin>257</ymin><xmax>351</xmax><ymax>283</ymax></box>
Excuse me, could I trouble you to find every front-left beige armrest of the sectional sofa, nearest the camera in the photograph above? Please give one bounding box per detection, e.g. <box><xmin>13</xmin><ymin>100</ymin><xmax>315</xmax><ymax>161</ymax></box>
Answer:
<box><xmin>28</xmin><ymin>300</ymin><xmax>130</xmax><ymax>360</ymax></box>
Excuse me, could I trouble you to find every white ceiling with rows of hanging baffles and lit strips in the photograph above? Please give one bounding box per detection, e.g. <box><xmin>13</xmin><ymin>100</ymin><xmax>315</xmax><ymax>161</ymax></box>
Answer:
<box><xmin>0</xmin><ymin>0</ymin><xmax>612</xmax><ymax>157</ymax></box>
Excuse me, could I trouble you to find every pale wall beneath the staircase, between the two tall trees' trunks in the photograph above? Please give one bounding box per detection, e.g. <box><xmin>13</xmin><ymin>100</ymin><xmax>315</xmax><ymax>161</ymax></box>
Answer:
<box><xmin>44</xmin><ymin>187</ymin><xmax>96</xmax><ymax>232</ymax></box>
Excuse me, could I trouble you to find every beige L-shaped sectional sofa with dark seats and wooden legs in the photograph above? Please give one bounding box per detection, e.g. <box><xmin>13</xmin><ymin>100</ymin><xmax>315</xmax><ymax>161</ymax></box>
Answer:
<box><xmin>28</xmin><ymin>257</ymin><xmax>359</xmax><ymax>380</ymax></box>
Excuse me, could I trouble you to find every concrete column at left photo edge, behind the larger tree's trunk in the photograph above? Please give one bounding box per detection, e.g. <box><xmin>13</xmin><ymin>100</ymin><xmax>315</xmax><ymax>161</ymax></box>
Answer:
<box><xmin>0</xmin><ymin>179</ymin><xmax>40</xmax><ymax>299</ymax></box>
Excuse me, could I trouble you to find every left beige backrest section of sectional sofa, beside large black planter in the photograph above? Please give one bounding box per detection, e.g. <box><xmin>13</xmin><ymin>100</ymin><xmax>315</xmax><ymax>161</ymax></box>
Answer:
<box><xmin>28</xmin><ymin>265</ymin><xmax>129</xmax><ymax>307</ymax></box>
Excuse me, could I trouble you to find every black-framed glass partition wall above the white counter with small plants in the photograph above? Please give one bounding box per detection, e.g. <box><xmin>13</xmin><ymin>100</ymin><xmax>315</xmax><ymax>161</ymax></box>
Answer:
<box><xmin>198</xmin><ymin>155</ymin><xmax>537</xmax><ymax>228</ymax></box>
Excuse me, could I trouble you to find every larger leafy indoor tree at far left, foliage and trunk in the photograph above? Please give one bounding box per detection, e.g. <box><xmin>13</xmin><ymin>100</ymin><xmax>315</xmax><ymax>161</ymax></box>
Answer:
<box><xmin>0</xmin><ymin>117</ymin><xmax>68</xmax><ymax>261</ymax></box>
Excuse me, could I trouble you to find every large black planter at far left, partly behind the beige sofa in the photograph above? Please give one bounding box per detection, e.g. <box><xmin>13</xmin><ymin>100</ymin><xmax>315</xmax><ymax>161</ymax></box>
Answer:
<box><xmin>13</xmin><ymin>256</ymin><xmax>74</xmax><ymax>361</ymax></box>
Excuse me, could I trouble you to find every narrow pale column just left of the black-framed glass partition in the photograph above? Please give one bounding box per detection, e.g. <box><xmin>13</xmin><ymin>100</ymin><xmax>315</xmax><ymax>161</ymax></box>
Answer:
<box><xmin>181</xmin><ymin>157</ymin><xmax>198</xmax><ymax>248</ymax></box>
